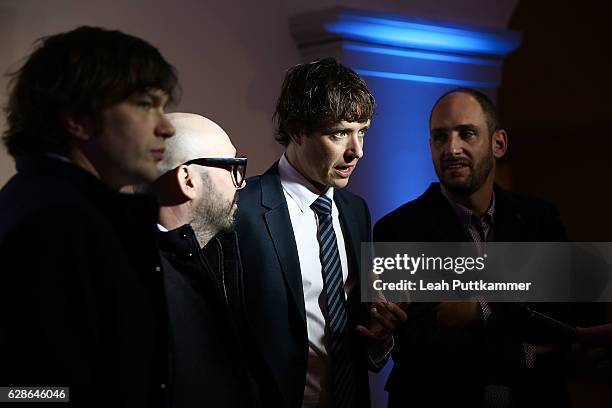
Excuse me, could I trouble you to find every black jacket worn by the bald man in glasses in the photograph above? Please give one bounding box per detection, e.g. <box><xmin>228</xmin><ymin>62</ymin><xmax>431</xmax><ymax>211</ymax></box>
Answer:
<box><xmin>160</xmin><ymin>225</ymin><xmax>258</xmax><ymax>408</ymax></box>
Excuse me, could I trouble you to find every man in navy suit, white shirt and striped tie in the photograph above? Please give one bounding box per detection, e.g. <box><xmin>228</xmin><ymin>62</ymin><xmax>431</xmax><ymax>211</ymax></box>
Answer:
<box><xmin>237</xmin><ymin>58</ymin><xmax>405</xmax><ymax>407</ymax></box>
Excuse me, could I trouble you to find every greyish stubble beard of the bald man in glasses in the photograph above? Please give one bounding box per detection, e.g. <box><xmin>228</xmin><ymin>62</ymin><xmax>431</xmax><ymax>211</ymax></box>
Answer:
<box><xmin>191</xmin><ymin>175</ymin><xmax>238</xmax><ymax>246</ymax></box>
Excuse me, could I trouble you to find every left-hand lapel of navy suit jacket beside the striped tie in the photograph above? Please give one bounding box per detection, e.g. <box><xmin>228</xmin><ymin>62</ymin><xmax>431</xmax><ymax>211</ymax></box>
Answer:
<box><xmin>261</xmin><ymin>163</ymin><xmax>306</xmax><ymax>324</ymax></box>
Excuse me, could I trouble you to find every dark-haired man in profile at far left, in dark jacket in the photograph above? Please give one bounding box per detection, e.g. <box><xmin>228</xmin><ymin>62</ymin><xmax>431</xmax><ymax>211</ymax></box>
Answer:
<box><xmin>0</xmin><ymin>27</ymin><xmax>177</xmax><ymax>407</ymax></box>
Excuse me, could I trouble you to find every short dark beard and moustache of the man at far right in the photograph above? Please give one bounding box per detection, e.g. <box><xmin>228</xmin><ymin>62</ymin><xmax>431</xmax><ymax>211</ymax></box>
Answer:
<box><xmin>435</xmin><ymin>151</ymin><xmax>494</xmax><ymax>197</ymax></box>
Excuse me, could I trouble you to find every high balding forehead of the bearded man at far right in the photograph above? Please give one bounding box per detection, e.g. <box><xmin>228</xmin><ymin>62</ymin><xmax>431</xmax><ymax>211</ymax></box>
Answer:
<box><xmin>430</xmin><ymin>92</ymin><xmax>486</xmax><ymax>129</ymax></box>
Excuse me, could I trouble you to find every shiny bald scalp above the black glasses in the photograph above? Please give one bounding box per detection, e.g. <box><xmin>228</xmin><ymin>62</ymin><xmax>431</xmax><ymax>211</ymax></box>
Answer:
<box><xmin>158</xmin><ymin>113</ymin><xmax>236</xmax><ymax>174</ymax></box>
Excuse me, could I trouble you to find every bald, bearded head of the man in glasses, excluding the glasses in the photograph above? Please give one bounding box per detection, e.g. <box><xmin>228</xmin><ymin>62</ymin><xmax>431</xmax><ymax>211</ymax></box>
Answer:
<box><xmin>152</xmin><ymin>113</ymin><xmax>238</xmax><ymax>246</ymax></box>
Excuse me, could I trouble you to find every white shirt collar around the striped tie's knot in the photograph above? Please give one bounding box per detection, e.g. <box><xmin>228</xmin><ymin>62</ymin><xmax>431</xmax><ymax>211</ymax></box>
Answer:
<box><xmin>278</xmin><ymin>154</ymin><xmax>338</xmax><ymax>214</ymax></box>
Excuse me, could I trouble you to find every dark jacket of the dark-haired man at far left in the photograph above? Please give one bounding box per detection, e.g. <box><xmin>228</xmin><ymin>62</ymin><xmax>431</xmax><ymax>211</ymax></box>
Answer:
<box><xmin>0</xmin><ymin>157</ymin><xmax>167</xmax><ymax>407</ymax></box>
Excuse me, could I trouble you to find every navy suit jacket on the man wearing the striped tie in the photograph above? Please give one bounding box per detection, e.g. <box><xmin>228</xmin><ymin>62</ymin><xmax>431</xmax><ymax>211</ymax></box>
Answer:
<box><xmin>236</xmin><ymin>164</ymin><xmax>371</xmax><ymax>407</ymax></box>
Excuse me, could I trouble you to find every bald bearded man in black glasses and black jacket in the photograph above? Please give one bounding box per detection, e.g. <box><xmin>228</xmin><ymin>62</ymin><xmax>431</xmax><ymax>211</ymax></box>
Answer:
<box><xmin>152</xmin><ymin>113</ymin><xmax>258</xmax><ymax>408</ymax></box>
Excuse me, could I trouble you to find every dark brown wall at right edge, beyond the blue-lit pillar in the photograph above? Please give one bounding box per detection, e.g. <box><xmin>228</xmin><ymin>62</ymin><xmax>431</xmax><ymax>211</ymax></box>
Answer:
<box><xmin>499</xmin><ymin>0</ymin><xmax>612</xmax><ymax>241</ymax></box>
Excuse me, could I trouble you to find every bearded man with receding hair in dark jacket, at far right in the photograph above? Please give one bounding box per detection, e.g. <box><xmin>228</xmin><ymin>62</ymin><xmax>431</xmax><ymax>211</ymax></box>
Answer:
<box><xmin>374</xmin><ymin>88</ymin><xmax>568</xmax><ymax>407</ymax></box>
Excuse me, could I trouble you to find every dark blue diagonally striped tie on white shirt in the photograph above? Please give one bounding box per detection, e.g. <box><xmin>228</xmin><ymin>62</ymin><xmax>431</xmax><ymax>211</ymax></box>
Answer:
<box><xmin>310</xmin><ymin>195</ymin><xmax>355</xmax><ymax>408</ymax></box>
